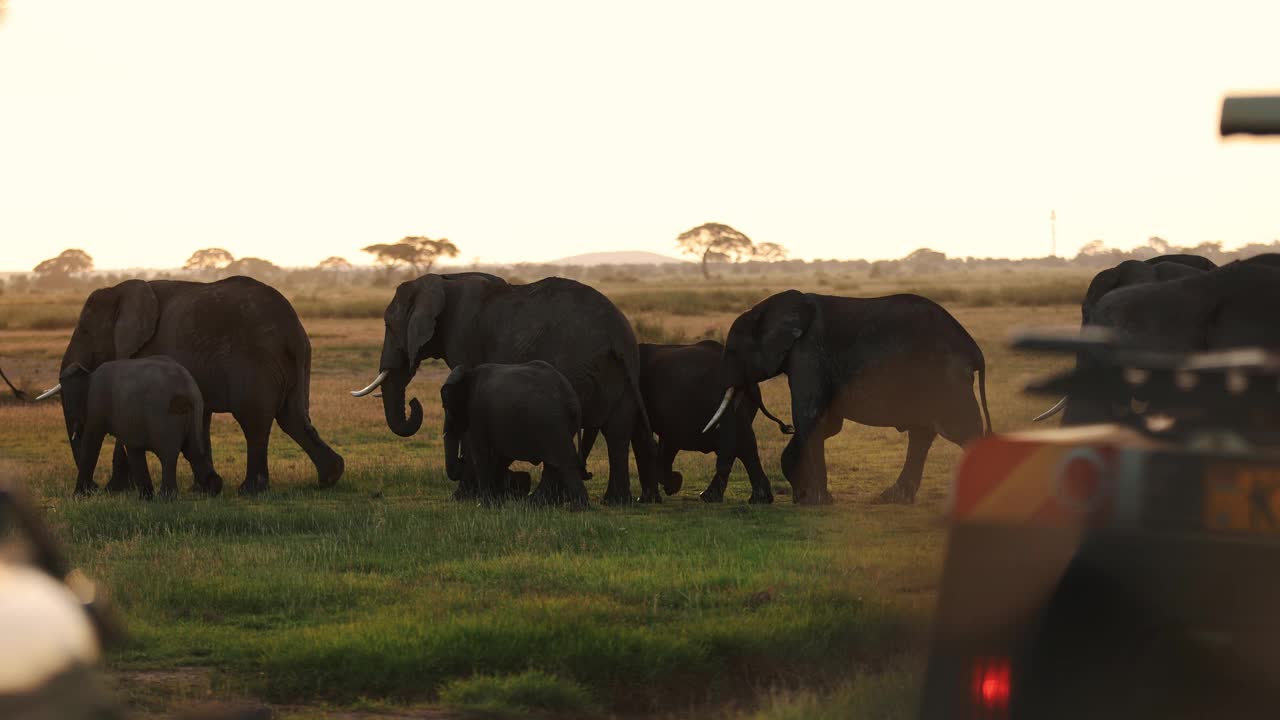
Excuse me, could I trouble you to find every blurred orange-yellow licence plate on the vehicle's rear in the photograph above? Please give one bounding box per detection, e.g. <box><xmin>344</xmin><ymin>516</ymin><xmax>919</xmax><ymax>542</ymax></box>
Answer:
<box><xmin>1204</xmin><ymin>465</ymin><xmax>1280</xmax><ymax>534</ymax></box>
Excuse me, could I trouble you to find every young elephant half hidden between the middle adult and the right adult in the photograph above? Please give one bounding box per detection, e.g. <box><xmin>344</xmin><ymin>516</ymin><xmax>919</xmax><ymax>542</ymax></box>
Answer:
<box><xmin>629</xmin><ymin>340</ymin><xmax>791</xmax><ymax>503</ymax></box>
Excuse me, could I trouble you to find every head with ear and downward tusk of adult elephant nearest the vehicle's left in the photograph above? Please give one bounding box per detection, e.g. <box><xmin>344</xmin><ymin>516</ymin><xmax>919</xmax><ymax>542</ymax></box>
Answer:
<box><xmin>703</xmin><ymin>290</ymin><xmax>814</xmax><ymax>432</ymax></box>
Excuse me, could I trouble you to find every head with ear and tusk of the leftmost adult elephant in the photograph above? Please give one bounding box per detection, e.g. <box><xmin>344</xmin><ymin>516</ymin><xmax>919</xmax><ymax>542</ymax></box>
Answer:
<box><xmin>36</xmin><ymin>279</ymin><xmax>160</xmax><ymax>400</ymax></box>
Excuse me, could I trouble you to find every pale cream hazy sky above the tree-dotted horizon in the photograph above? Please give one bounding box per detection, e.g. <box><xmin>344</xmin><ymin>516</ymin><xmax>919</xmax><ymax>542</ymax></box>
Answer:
<box><xmin>0</xmin><ymin>0</ymin><xmax>1280</xmax><ymax>270</ymax></box>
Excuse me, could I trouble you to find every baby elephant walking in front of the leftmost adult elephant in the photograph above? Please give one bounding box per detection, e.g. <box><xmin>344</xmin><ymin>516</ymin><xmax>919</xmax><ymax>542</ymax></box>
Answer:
<box><xmin>60</xmin><ymin>355</ymin><xmax>223</xmax><ymax>500</ymax></box>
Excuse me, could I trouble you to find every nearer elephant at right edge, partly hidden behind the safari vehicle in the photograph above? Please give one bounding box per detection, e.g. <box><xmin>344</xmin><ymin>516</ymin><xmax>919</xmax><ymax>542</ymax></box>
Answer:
<box><xmin>1062</xmin><ymin>254</ymin><xmax>1280</xmax><ymax>425</ymax></box>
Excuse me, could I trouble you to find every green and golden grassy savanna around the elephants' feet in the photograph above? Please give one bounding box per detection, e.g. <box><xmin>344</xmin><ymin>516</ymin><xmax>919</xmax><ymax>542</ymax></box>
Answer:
<box><xmin>0</xmin><ymin>271</ymin><xmax>1083</xmax><ymax>719</ymax></box>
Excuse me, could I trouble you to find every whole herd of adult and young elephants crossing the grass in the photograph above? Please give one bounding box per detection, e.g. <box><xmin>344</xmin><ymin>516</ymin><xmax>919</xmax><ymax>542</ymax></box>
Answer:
<box><xmin>30</xmin><ymin>255</ymin><xmax>1280</xmax><ymax>507</ymax></box>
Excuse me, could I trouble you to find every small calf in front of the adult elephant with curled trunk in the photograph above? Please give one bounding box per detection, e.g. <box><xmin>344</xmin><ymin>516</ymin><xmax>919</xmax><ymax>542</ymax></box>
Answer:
<box><xmin>440</xmin><ymin>360</ymin><xmax>588</xmax><ymax>507</ymax></box>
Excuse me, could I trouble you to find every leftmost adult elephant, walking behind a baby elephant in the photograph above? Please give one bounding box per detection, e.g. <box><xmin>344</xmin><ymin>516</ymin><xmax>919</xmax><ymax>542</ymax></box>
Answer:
<box><xmin>40</xmin><ymin>275</ymin><xmax>344</xmax><ymax>493</ymax></box>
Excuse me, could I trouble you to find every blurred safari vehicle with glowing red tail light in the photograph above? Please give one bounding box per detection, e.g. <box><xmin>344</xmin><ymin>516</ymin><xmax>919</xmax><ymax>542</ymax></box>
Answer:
<box><xmin>919</xmin><ymin>92</ymin><xmax>1280</xmax><ymax>720</ymax></box>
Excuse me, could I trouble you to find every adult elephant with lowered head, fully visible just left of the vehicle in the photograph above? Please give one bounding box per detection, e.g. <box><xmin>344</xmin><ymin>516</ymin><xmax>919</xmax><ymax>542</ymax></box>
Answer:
<box><xmin>707</xmin><ymin>290</ymin><xmax>991</xmax><ymax>503</ymax></box>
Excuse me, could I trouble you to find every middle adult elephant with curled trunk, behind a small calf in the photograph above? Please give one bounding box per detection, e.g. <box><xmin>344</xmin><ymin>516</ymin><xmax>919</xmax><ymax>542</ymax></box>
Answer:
<box><xmin>352</xmin><ymin>273</ymin><xmax>662</xmax><ymax>503</ymax></box>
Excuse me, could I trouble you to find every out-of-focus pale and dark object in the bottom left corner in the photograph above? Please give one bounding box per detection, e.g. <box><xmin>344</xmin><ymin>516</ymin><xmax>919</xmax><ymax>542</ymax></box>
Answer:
<box><xmin>0</xmin><ymin>483</ymin><xmax>123</xmax><ymax>720</ymax></box>
